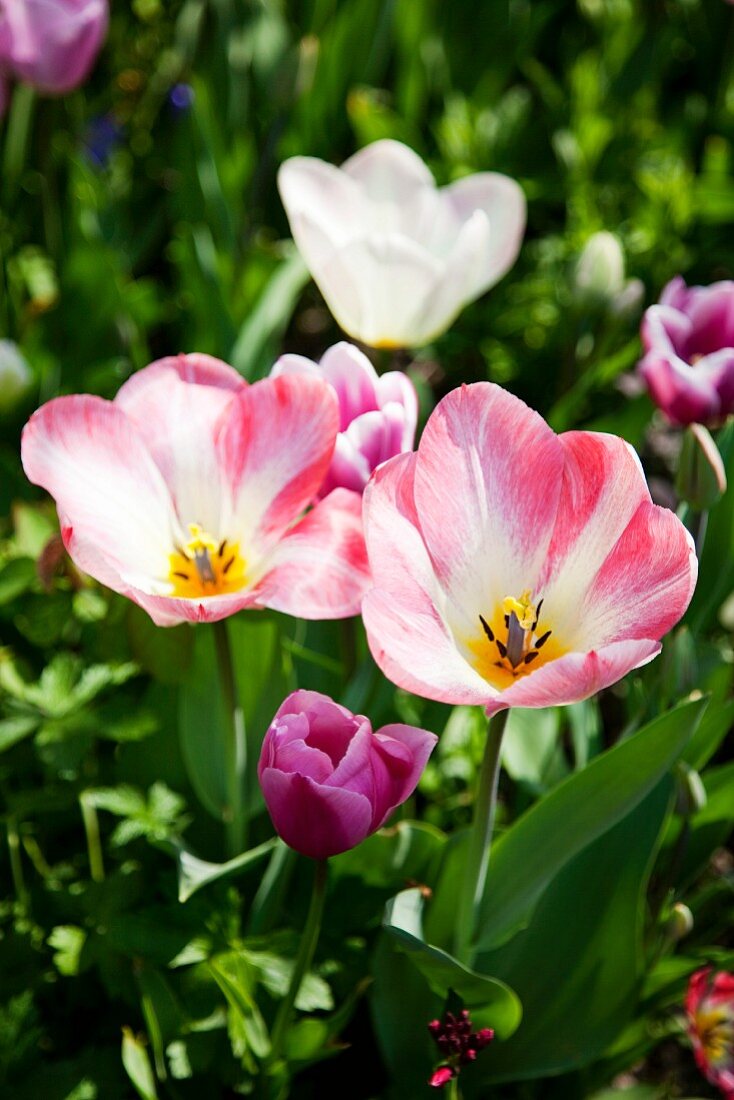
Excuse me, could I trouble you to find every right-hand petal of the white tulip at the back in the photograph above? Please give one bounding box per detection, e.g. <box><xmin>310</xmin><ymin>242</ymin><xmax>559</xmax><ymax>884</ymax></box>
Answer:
<box><xmin>441</xmin><ymin>172</ymin><xmax>526</xmax><ymax>296</ymax></box>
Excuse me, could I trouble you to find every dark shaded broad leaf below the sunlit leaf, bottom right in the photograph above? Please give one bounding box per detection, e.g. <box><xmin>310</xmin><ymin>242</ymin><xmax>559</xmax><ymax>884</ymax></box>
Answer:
<box><xmin>472</xmin><ymin>776</ymin><xmax>673</xmax><ymax>1078</ymax></box>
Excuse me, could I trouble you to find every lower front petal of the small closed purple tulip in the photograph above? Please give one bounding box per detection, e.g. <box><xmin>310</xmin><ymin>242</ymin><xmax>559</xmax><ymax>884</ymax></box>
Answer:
<box><xmin>260</xmin><ymin>768</ymin><xmax>372</xmax><ymax>859</ymax></box>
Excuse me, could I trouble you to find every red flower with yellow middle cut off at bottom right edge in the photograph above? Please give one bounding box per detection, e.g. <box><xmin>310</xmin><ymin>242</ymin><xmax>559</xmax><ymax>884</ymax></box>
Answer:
<box><xmin>686</xmin><ymin>967</ymin><xmax>734</xmax><ymax>1100</ymax></box>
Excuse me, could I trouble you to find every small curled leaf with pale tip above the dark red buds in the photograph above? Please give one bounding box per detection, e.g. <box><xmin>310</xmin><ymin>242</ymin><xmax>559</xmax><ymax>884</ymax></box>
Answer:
<box><xmin>383</xmin><ymin>887</ymin><xmax>523</xmax><ymax>1038</ymax></box>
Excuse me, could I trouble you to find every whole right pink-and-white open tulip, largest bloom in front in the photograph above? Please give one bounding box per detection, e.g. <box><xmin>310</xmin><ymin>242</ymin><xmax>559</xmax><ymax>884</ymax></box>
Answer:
<box><xmin>362</xmin><ymin>382</ymin><xmax>697</xmax><ymax>715</ymax></box>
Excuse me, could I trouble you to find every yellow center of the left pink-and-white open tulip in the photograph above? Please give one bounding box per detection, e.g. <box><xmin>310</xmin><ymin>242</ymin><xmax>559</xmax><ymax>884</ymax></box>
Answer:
<box><xmin>168</xmin><ymin>524</ymin><xmax>247</xmax><ymax>600</ymax></box>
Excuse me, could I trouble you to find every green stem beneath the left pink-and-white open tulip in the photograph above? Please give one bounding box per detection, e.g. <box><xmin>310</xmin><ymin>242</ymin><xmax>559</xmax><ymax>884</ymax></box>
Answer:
<box><xmin>213</xmin><ymin>619</ymin><xmax>248</xmax><ymax>859</ymax></box>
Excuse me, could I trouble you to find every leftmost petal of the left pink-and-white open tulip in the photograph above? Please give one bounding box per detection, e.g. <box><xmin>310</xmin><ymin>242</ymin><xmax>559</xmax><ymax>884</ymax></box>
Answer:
<box><xmin>22</xmin><ymin>396</ymin><xmax>175</xmax><ymax>592</ymax></box>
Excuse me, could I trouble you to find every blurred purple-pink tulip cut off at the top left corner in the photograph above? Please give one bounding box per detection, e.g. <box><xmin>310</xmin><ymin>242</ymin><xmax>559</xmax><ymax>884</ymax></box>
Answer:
<box><xmin>0</xmin><ymin>0</ymin><xmax>109</xmax><ymax>109</ymax></box>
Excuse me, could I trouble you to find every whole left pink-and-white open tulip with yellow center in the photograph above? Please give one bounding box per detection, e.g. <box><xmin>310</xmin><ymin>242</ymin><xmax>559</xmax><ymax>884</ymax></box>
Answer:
<box><xmin>22</xmin><ymin>355</ymin><xmax>368</xmax><ymax>626</ymax></box>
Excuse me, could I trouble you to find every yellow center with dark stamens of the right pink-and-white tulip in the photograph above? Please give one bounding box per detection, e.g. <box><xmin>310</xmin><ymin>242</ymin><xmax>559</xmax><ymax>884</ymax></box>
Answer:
<box><xmin>468</xmin><ymin>590</ymin><xmax>568</xmax><ymax>689</ymax></box>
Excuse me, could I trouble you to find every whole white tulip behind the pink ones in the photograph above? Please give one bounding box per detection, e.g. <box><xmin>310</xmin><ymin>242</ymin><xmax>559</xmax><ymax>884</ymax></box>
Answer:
<box><xmin>278</xmin><ymin>141</ymin><xmax>525</xmax><ymax>348</ymax></box>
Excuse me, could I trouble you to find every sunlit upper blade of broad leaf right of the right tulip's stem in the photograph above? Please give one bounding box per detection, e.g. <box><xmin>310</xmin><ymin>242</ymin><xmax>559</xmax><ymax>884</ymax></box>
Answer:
<box><xmin>470</xmin><ymin>700</ymin><xmax>705</xmax><ymax>950</ymax></box>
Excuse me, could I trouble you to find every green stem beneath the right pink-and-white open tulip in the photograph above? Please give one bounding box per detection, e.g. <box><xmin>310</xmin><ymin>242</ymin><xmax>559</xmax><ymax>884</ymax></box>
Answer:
<box><xmin>456</xmin><ymin>711</ymin><xmax>510</xmax><ymax>965</ymax></box>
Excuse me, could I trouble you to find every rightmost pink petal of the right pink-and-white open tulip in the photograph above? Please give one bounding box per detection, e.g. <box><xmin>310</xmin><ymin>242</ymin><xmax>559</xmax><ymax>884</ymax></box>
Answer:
<box><xmin>581</xmin><ymin>502</ymin><xmax>698</xmax><ymax>646</ymax></box>
